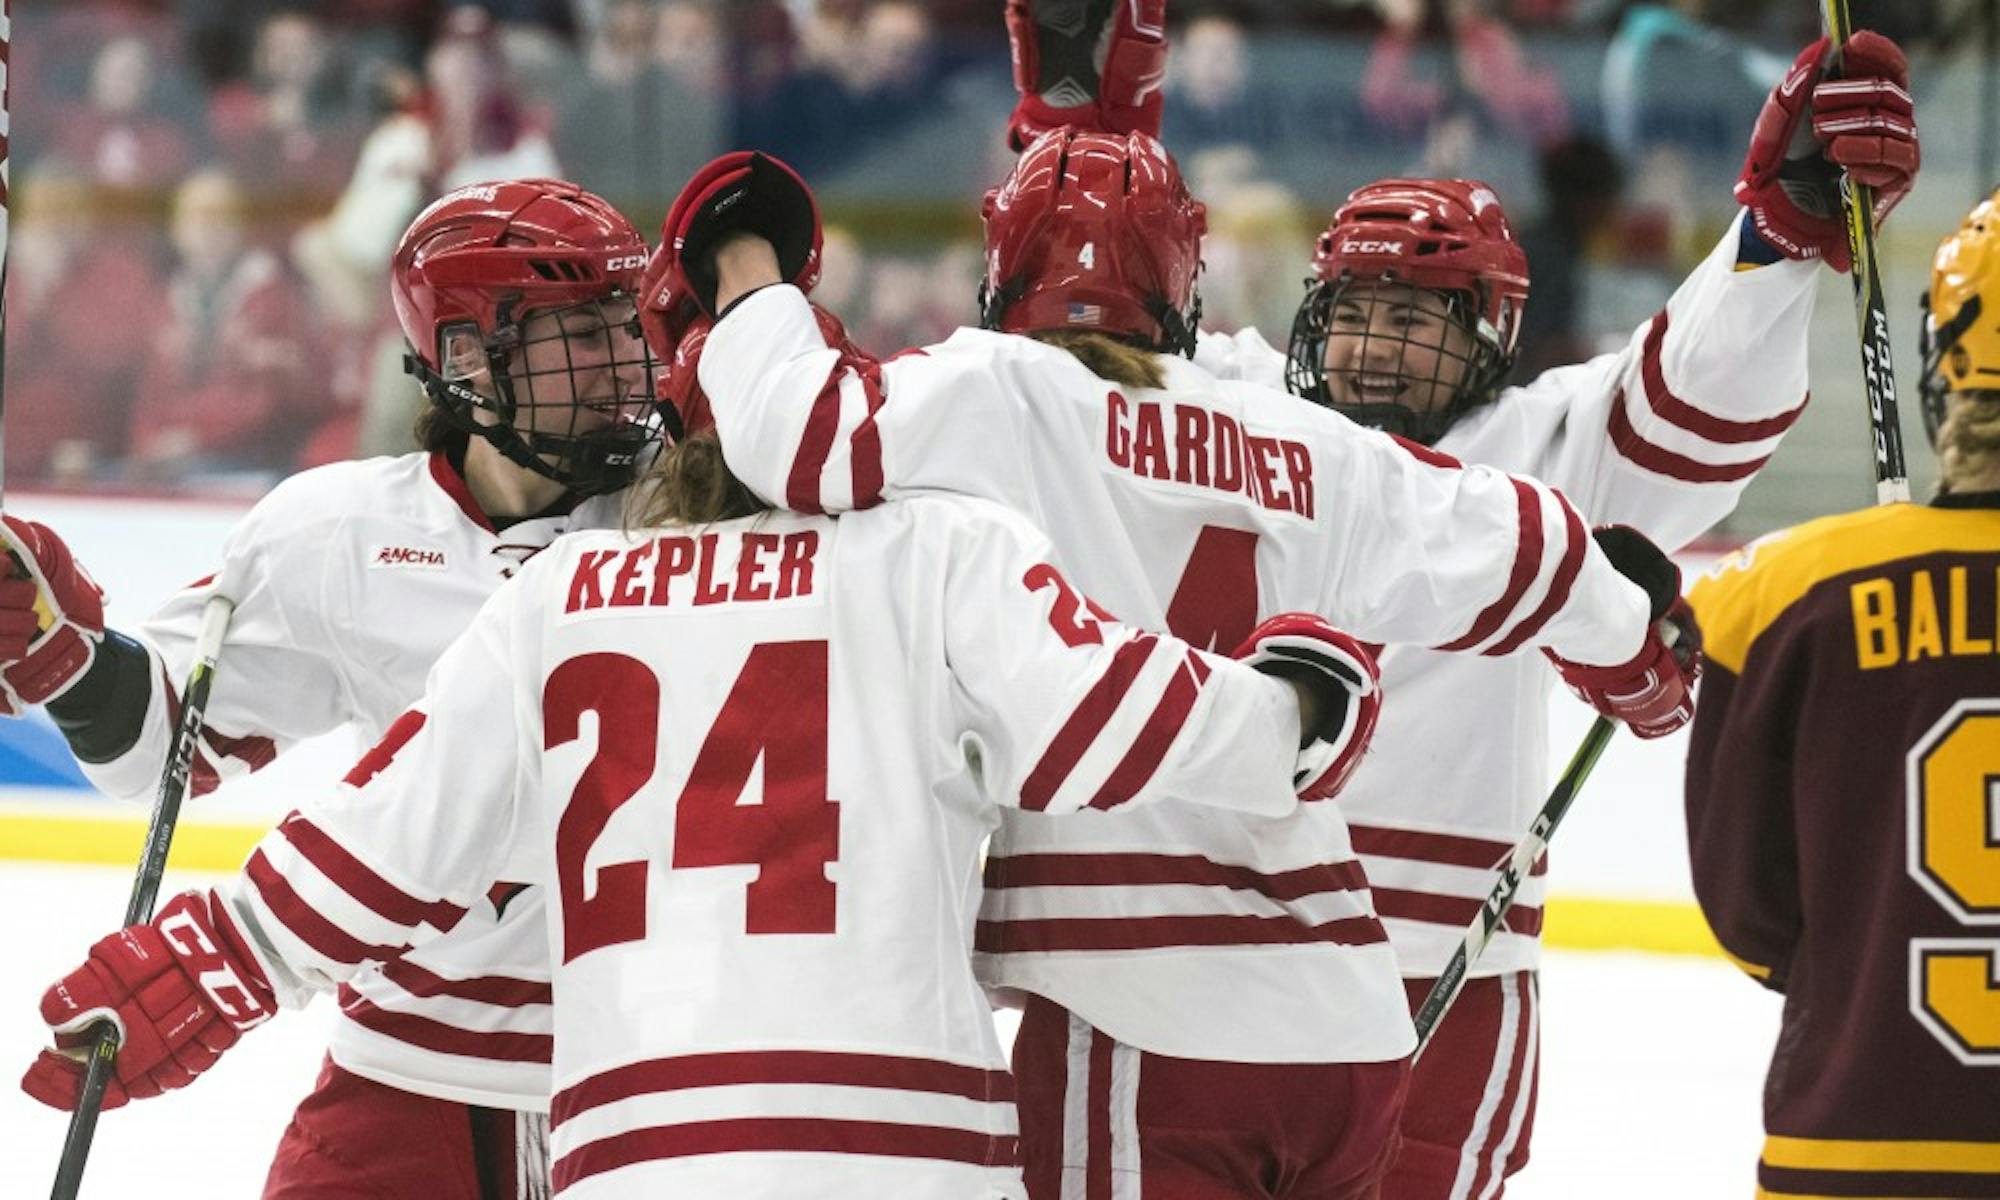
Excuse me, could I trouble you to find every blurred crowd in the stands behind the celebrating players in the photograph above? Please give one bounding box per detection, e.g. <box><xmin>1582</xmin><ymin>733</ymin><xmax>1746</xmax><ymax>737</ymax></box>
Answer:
<box><xmin>6</xmin><ymin>0</ymin><xmax>1968</xmax><ymax>488</ymax></box>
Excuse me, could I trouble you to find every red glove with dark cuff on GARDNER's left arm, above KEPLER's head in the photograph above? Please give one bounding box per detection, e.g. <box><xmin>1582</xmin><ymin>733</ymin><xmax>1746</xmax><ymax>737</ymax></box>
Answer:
<box><xmin>646</xmin><ymin>150</ymin><xmax>820</xmax><ymax>318</ymax></box>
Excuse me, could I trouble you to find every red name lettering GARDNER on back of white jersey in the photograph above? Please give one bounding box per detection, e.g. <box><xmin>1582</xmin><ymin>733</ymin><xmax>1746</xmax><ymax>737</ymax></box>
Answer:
<box><xmin>1104</xmin><ymin>392</ymin><xmax>1314</xmax><ymax>520</ymax></box>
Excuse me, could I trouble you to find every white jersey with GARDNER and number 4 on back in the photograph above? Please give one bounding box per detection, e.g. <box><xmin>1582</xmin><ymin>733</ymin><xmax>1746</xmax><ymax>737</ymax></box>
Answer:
<box><xmin>700</xmin><ymin>286</ymin><xmax>1648</xmax><ymax>1062</ymax></box>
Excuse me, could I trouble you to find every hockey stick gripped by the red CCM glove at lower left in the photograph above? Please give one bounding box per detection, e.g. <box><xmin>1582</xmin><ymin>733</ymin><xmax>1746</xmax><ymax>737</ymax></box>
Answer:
<box><xmin>48</xmin><ymin>596</ymin><xmax>236</xmax><ymax>1200</ymax></box>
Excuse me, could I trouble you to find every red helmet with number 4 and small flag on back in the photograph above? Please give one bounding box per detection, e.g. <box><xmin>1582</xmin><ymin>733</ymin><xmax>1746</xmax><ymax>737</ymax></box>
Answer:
<box><xmin>980</xmin><ymin>128</ymin><xmax>1208</xmax><ymax>356</ymax></box>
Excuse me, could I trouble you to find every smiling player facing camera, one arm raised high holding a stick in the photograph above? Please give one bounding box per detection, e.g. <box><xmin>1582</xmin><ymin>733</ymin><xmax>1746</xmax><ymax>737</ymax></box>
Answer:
<box><xmin>1168</xmin><ymin>32</ymin><xmax>1918</xmax><ymax>1200</ymax></box>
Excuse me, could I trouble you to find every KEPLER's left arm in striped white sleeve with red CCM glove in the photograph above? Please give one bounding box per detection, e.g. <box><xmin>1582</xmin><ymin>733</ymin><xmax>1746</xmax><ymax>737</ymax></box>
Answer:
<box><xmin>22</xmin><ymin>576</ymin><xmax>536</xmax><ymax>1108</ymax></box>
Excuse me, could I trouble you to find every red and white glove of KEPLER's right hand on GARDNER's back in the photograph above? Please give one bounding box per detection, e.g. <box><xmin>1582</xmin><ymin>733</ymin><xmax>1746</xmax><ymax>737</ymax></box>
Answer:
<box><xmin>1232</xmin><ymin>612</ymin><xmax>1382</xmax><ymax>800</ymax></box>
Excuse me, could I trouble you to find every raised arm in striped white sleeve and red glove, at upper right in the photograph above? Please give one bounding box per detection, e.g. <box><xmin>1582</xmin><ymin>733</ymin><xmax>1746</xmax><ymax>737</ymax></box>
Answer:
<box><xmin>1530</xmin><ymin>32</ymin><xmax>1920</xmax><ymax>550</ymax></box>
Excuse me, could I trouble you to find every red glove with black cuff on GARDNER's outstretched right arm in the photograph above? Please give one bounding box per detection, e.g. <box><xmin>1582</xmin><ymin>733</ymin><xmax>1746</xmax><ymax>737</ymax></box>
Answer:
<box><xmin>1548</xmin><ymin>526</ymin><xmax>1702</xmax><ymax>738</ymax></box>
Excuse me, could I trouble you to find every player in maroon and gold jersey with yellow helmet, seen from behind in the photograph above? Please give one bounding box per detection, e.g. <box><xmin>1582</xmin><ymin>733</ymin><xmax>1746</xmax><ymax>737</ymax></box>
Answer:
<box><xmin>1686</xmin><ymin>192</ymin><xmax>2000</xmax><ymax>1198</ymax></box>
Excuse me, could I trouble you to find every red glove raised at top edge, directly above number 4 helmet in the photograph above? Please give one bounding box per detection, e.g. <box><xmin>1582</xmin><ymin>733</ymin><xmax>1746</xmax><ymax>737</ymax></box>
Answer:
<box><xmin>1006</xmin><ymin>0</ymin><xmax>1166</xmax><ymax>152</ymax></box>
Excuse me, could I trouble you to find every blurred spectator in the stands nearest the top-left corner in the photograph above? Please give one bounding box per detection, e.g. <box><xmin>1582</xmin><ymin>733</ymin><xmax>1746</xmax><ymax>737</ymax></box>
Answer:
<box><xmin>52</xmin><ymin>36</ymin><xmax>192</xmax><ymax>194</ymax></box>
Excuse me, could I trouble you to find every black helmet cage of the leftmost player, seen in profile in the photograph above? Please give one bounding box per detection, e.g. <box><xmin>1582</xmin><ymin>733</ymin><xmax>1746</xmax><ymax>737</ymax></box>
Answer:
<box><xmin>404</xmin><ymin>292</ymin><xmax>664</xmax><ymax>496</ymax></box>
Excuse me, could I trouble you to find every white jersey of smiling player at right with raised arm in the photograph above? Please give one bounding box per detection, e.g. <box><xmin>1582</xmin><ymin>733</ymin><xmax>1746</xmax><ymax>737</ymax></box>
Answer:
<box><xmin>1196</xmin><ymin>213</ymin><xmax>1818</xmax><ymax>978</ymax></box>
